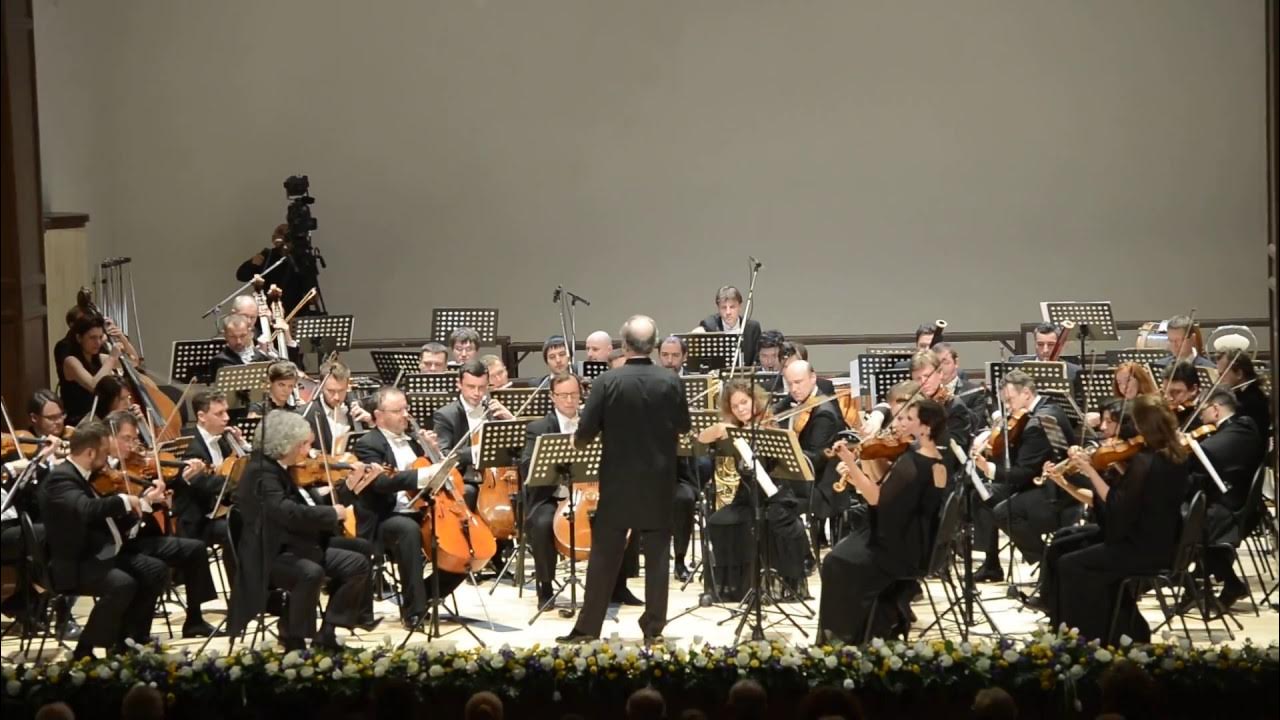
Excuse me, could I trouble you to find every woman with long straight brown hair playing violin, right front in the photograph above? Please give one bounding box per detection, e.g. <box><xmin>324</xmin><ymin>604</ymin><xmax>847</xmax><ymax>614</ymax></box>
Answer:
<box><xmin>1044</xmin><ymin>395</ymin><xmax>1188</xmax><ymax>644</ymax></box>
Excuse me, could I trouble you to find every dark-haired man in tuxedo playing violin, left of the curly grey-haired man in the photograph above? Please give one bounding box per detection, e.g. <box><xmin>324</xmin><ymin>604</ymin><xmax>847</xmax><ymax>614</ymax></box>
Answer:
<box><xmin>40</xmin><ymin>420</ymin><xmax>169</xmax><ymax>659</ymax></box>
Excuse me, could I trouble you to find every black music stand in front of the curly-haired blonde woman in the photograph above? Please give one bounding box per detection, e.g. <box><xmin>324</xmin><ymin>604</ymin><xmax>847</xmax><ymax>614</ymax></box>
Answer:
<box><xmin>718</xmin><ymin>424</ymin><xmax>814</xmax><ymax>641</ymax></box>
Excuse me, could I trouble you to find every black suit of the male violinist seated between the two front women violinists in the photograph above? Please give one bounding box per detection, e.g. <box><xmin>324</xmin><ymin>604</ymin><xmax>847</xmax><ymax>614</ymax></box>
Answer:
<box><xmin>975</xmin><ymin>396</ymin><xmax>1082</xmax><ymax>571</ymax></box>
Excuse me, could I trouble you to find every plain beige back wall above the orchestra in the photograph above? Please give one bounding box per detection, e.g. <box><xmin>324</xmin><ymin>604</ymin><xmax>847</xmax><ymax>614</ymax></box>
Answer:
<box><xmin>36</xmin><ymin>0</ymin><xmax>1267</xmax><ymax>370</ymax></box>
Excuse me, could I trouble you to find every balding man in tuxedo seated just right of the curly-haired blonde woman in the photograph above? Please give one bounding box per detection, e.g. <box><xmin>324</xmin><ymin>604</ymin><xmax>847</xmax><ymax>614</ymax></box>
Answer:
<box><xmin>773</xmin><ymin>360</ymin><xmax>847</xmax><ymax>548</ymax></box>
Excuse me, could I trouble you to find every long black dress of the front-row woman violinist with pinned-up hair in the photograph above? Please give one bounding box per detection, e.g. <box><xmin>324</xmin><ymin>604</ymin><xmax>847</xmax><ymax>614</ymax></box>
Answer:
<box><xmin>818</xmin><ymin>450</ymin><xmax>945</xmax><ymax>643</ymax></box>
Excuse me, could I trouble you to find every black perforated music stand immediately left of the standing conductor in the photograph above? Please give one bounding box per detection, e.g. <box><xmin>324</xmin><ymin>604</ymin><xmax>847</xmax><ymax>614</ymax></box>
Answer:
<box><xmin>525</xmin><ymin>433</ymin><xmax>604</xmax><ymax>625</ymax></box>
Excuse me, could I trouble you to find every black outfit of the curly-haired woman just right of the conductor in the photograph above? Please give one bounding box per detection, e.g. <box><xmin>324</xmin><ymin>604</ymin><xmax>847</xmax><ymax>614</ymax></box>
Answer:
<box><xmin>707</xmin><ymin>441</ymin><xmax>810</xmax><ymax>601</ymax></box>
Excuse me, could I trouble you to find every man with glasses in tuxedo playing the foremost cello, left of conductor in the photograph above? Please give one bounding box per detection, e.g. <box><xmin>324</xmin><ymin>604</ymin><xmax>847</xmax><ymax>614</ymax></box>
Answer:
<box><xmin>353</xmin><ymin>386</ymin><xmax>450</xmax><ymax>629</ymax></box>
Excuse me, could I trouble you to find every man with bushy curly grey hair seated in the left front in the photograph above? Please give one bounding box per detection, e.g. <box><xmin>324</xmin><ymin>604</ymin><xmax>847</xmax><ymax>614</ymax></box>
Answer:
<box><xmin>227</xmin><ymin>411</ymin><xmax>368</xmax><ymax>651</ymax></box>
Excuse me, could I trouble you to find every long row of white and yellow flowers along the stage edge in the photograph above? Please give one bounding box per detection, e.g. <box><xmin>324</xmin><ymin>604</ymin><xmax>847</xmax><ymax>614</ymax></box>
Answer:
<box><xmin>3</xmin><ymin>626</ymin><xmax>1280</xmax><ymax>707</ymax></box>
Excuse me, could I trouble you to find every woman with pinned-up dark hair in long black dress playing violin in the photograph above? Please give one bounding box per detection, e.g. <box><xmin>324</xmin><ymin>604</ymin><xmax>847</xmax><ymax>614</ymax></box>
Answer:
<box><xmin>817</xmin><ymin>400</ymin><xmax>947</xmax><ymax>644</ymax></box>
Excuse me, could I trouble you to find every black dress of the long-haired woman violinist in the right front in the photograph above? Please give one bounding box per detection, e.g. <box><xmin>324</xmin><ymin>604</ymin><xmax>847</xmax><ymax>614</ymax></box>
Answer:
<box><xmin>1044</xmin><ymin>450</ymin><xmax>1188</xmax><ymax>643</ymax></box>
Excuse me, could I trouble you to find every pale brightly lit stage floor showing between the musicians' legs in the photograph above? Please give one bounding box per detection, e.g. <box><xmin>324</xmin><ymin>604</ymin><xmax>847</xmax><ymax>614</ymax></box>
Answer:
<box><xmin>3</xmin><ymin>532</ymin><xmax>1280</xmax><ymax>662</ymax></box>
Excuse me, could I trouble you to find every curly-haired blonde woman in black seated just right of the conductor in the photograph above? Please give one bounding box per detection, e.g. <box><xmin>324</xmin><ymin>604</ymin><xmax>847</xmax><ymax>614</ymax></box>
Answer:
<box><xmin>698</xmin><ymin>378</ymin><xmax>809</xmax><ymax>601</ymax></box>
